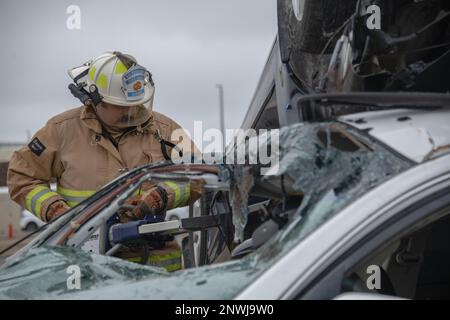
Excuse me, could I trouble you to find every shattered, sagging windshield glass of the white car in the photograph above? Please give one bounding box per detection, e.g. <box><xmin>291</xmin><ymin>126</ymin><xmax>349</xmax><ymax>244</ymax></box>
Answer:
<box><xmin>0</xmin><ymin>122</ymin><xmax>411</xmax><ymax>299</ymax></box>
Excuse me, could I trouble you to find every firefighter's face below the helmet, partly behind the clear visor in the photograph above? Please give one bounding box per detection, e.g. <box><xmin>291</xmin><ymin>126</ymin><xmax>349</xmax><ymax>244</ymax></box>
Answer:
<box><xmin>97</xmin><ymin>102</ymin><xmax>148</xmax><ymax>129</ymax></box>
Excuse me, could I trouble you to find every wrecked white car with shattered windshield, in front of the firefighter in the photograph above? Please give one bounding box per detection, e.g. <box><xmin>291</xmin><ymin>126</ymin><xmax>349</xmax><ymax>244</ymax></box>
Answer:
<box><xmin>0</xmin><ymin>94</ymin><xmax>450</xmax><ymax>299</ymax></box>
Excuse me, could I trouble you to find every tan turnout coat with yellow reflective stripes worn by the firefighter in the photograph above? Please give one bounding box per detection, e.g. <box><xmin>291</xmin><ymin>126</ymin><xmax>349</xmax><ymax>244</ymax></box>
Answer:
<box><xmin>8</xmin><ymin>106</ymin><xmax>196</xmax><ymax>220</ymax></box>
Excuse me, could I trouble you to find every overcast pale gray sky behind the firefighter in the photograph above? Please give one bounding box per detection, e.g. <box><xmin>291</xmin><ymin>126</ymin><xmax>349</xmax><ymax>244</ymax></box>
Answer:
<box><xmin>0</xmin><ymin>0</ymin><xmax>276</xmax><ymax>142</ymax></box>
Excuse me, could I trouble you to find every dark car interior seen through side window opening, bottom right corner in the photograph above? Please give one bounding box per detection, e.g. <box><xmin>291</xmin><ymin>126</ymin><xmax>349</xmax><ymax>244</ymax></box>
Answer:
<box><xmin>342</xmin><ymin>214</ymin><xmax>450</xmax><ymax>300</ymax></box>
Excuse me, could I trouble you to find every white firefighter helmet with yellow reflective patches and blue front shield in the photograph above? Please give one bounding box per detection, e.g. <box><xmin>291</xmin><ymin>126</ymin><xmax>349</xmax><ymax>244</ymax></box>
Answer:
<box><xmin>68</xmin><ymin>51</ymin><xmax>155</xmax><ymax>110</ymax></box>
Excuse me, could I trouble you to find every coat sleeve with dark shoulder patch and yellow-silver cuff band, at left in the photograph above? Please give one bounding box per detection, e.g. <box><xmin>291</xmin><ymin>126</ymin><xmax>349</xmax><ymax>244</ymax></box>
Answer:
<box><xmin>7</xmin><ymin>122</ymin><xmax>64</xmax><ymax>221</ymax></box>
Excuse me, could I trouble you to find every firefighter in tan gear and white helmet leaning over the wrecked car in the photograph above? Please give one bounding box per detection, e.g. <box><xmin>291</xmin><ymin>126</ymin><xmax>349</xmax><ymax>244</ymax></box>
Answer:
<box><xmin>7</xmin><ymin>52</ymin><xmax>200</xmax><ymax>270</ymax></box>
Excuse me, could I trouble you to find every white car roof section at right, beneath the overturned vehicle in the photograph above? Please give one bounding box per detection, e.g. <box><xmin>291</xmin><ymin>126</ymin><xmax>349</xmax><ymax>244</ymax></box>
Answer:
<box><xmin>338</xmin><ymin>109</ymin><xmax>450</xmax><ymax>163</ymax></box>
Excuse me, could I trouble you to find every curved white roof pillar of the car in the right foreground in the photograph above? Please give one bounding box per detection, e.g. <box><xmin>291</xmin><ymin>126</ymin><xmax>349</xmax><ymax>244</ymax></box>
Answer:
<box><xmin>236</xmin><ymin>155</ymin><xmax>450</xmax><ymax>299</ymax></box>
